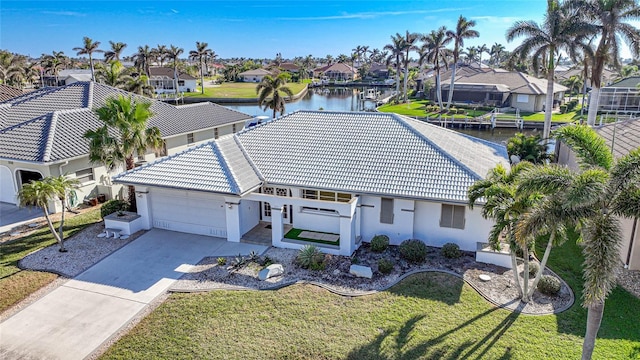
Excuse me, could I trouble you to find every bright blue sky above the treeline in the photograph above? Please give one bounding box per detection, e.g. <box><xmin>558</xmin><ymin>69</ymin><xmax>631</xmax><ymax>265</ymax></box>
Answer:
<box><xmin>0</xmin><ymin>0</ymin><xmax>631</xmax><ymax>59</ymax></box>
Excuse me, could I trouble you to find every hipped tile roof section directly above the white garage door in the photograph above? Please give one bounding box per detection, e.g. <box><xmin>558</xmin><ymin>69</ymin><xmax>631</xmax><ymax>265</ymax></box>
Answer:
<box><xmin>113</xmin><ymin>136</ymin><xmax>261</xmax><ymax>195</ymax></box>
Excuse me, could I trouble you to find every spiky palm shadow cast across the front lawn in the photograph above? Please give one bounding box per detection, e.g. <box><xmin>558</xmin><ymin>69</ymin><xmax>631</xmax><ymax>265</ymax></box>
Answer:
<box><xmin>347</xmin><ymin>308</ymin><xmax>519</xmax><ymax>360</ymax></box>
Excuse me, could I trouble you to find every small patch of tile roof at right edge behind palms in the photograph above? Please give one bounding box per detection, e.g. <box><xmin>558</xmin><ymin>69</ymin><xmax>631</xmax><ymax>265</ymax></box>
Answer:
<box><xmin>595</xmin><ymin>118</ymin><xmax>640</xmax><ymax>158</ymax></box>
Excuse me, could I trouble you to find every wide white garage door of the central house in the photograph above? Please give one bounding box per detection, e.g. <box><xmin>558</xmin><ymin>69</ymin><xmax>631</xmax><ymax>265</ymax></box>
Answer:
<box><xmin>150</xmin><ymin>189</ymin><xmax>227</xmax><ymax>237</ymax></box>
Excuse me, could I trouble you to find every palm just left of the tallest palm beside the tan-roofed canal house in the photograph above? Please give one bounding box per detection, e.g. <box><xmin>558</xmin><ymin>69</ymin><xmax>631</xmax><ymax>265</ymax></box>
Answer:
<box><xmin>420</xmin><ymin>26</ymin><xmax>451</xmax><ymax>112</ymax></box>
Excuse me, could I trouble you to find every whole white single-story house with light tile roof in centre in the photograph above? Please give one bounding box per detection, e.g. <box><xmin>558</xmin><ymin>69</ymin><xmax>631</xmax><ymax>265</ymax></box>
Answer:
<box><xmin>113</xmin><ymin>111</ymin><xmax>509</xmax><ymax>255</ymax></box>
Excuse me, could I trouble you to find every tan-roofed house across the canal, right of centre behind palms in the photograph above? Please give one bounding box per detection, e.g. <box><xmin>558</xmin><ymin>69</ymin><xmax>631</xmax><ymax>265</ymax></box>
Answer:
<box><xmin>431</xmin><ymin>69</ymin><xmax>568</xmax><ymax>112</ymax></box>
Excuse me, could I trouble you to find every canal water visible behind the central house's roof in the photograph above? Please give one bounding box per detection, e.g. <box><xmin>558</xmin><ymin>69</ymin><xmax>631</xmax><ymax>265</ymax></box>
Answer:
<box><xmin>220</xmin><ymin>87</ymin><xmax>536</xmax><ymax>144</ymax></box>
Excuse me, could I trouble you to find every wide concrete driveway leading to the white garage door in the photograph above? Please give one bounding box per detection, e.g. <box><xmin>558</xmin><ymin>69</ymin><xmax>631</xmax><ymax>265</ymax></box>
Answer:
<box><xmin>0</xmin><ymin>229</ymin><xmax>267</xmax><ymax>359</ymax></box>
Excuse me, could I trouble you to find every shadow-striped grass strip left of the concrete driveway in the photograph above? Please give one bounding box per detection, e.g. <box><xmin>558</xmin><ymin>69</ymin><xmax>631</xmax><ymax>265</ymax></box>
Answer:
<box><xmin>0</xmin><ymin>209</ymin><xmax>101</xmax><ymax>312</ymax></box>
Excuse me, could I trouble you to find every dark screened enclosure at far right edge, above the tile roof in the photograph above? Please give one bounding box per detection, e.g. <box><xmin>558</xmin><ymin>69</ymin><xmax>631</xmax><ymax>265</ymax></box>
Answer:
<box><xmin>598</xmin><ymin>76</ymin><xmax>640</xmax><ymax>116</ymax></box>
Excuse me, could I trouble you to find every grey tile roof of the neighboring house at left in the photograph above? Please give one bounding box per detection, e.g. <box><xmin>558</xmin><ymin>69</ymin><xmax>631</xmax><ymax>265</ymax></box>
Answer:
<box><xmin>0</xmin><ymin>82</ymin><xmax>251</xmax><ymax>162</ymax></box>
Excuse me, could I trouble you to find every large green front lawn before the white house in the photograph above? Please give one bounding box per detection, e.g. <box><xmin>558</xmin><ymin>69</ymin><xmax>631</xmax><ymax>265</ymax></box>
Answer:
<box><xmin>102</xmin><ymin>229</ymin><xmax>640</xmax><ymax>359</ymax></box>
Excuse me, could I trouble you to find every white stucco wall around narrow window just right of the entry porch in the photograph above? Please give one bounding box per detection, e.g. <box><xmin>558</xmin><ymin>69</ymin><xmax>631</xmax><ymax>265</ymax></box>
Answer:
<box><xmin>360</xmin><ymin>196</ymin><xmax>414</xmax><ymax>245</ymax></box>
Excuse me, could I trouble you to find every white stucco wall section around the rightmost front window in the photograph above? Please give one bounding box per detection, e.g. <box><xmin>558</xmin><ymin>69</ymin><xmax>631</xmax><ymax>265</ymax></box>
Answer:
<box><xmin>413</xmin><ymin>201</ymin><xmax>493</xmax><ymax>251</ymax></box>
